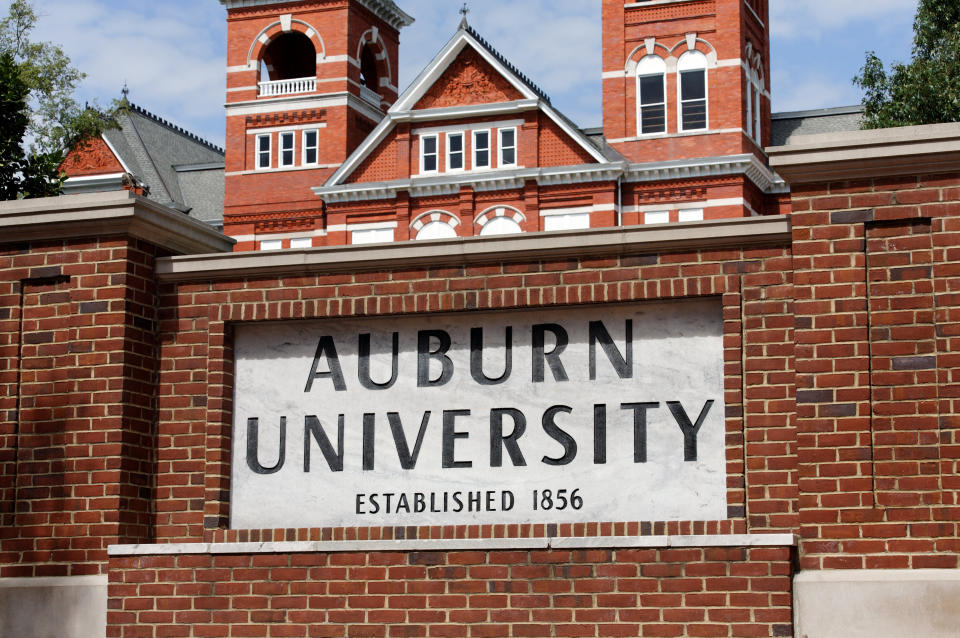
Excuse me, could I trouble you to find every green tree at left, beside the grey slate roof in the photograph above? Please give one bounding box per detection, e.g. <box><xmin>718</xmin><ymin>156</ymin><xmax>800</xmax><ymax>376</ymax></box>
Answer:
<box><xmin>0</xmin><ymin>0</ymin><xmax>116</xmax><ymax>199</ymax></box>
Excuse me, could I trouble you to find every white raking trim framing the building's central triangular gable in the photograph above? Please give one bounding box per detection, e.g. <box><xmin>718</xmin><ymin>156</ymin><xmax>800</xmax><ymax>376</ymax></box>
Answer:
<box><xmin>322</xmin><ymin>21</ymin><xmax>612</xmax><ymax>194</ymax></box>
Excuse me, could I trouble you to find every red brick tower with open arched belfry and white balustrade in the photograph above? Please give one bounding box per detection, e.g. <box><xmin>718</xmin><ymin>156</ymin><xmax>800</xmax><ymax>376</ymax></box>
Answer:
<box><xmin>220</xmin><ymin>0</ymin><xmax>413</xmax><ymax>250</ymax></box>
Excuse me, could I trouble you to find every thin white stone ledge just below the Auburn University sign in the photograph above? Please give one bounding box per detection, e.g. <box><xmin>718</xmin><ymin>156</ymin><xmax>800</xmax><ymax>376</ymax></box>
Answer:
<box><xmin>107</xmin><ymin>534</ymin><xmax>797</xmax><ymax>556</ymax></box>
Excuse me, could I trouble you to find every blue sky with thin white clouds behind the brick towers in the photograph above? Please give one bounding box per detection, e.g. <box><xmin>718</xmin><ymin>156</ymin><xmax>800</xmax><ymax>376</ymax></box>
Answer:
<box><xmin>9</xmin><ymin>0</ymin><xmax>917</xmax><ymax>144</ymax></box>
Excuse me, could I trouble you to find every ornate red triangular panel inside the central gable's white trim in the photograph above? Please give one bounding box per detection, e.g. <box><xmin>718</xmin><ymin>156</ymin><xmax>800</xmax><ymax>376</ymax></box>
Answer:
<box><xmin>414</xmin><ymin>47</ymin><xmax>523</xmax><ymax>109</ymax></box>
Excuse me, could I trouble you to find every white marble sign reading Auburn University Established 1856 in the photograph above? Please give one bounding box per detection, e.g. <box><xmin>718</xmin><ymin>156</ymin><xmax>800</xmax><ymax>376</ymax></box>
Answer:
<box><xmin>231</xmin><ymin>300</ymin><xmax>727</xmax><ymax>529</ymax></box>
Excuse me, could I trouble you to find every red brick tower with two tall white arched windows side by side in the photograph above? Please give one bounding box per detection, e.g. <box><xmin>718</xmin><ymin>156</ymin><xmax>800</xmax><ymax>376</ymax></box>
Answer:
<box><xmin>603</xmin><ymin>0</ymin><xmax>770</xmax><ymax>162</ymax></box>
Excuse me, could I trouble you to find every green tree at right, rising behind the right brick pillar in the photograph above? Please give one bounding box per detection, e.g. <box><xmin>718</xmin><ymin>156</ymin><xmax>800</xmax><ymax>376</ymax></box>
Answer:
<box><xmin>853</xmin><ymin>0</ymin><xmax>960</xmax><ymax>128</ymax></box>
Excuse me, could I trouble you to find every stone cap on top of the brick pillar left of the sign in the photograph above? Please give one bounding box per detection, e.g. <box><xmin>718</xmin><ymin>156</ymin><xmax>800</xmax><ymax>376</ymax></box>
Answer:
<box><xmin>0</xmin><ymin>191</ymin><xmax>236</xmax><ymax>254</ymax></box>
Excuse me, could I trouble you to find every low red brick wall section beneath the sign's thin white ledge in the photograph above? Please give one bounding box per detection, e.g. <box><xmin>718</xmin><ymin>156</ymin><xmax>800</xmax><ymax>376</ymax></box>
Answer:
<box><xmin>107</xmin><ymin>547</ymin><xmax>793</xmax><ymax>638</ymax></box>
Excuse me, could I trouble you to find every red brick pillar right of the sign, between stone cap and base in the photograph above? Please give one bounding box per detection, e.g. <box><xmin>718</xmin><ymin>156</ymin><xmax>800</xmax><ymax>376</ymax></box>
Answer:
<box><xmin>793</xmin><ymin>174</ymin><xmax>960</xmax><ymax>569</ymax></box>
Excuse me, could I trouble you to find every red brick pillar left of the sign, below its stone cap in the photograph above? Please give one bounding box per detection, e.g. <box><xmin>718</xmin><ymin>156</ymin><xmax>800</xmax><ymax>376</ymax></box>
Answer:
<box><xmin>0</xmin><ymin>239</ymin><xmax>163</xmax><ymax>577</ymax></box>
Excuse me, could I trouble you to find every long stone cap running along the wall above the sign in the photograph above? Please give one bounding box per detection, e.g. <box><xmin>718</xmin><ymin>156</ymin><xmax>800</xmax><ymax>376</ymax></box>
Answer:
<box><xmin>157</xmin><ymin>216</ymin><xmax>790</xmax><ymax>281</ymax></box>
